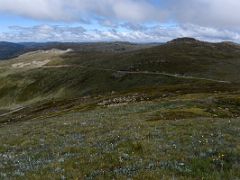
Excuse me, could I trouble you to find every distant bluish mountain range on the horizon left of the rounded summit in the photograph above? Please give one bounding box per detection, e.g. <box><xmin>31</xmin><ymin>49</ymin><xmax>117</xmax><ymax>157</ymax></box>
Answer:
<box><xmin>0</xmin><ymin>42</ymin><xmax>161</xmax><ymax>60</ymax></box>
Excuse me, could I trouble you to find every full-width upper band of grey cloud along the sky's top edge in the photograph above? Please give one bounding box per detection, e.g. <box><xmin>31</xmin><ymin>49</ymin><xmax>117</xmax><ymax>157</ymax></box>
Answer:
<box><xmin>0</xmin><ymin>0</ymin><xmax>240</xmax><ymax>29</ymax></box>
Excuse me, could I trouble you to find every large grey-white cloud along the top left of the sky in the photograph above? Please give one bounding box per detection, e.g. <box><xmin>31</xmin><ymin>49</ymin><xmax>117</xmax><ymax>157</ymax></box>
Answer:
<box><xmin>0</xmin><ymin>0</ymin><xmax>165</xmax><ymax>22</ymax></box>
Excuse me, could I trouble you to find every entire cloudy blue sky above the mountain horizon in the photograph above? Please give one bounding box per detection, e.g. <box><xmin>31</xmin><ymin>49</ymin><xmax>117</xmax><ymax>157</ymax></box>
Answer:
<box><xmin>0</xmin><ymin>0</ymin><xmax>240</xmax><ymax>43</ymax></box>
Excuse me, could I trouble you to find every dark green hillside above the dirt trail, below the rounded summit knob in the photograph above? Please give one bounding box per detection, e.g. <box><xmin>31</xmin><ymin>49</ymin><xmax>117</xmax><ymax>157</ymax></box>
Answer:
<box><xmin>59</xmin><ymin>41</ymin><xmax>240</xmax><ymax>82</ymax></box>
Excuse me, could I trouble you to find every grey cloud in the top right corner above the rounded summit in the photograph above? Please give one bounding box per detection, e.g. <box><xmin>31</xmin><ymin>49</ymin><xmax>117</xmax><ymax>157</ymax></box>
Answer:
<box><xmin>167</xmin><ymin>0</ymin><xmax>240</xmax><ymax>29</ymax></box>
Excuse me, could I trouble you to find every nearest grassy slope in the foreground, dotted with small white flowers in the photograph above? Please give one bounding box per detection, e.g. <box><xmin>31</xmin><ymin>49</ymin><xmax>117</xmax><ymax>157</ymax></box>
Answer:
<box><xmin>0</xmin><ymin>90</ymin><xmax>240</xmax><ymax>179</ymax></box>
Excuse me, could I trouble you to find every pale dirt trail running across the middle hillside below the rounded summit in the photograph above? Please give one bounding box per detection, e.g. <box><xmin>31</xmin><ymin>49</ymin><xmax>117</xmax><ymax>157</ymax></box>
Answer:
<box><xmin>41</xmin><ymin>65</ymin><xmax>231</xmax><ymax>84</ymax></box>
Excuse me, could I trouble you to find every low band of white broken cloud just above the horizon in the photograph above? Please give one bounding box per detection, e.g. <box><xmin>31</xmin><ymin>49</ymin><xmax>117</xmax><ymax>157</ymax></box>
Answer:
<box><xmin>0</xmin><ymin>24</ymin><xmax>240</xmax><ymax>43</ymax></box>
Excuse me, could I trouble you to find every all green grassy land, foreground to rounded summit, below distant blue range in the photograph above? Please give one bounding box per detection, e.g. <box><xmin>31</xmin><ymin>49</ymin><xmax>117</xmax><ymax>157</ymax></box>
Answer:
<box><xmin>0</xmin><ymin>38</ymin><xmax>240</xmax><ymax>179</ymax></box>
